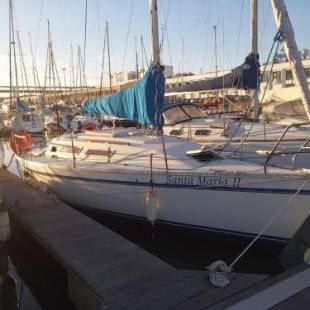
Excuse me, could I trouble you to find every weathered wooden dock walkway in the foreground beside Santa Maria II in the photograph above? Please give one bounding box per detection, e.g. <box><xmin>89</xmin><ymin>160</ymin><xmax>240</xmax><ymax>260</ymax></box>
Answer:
<box><xmin>0</xmin><ymin>169</ymin><xmax>308</xmax><ymax>309</ymax></box>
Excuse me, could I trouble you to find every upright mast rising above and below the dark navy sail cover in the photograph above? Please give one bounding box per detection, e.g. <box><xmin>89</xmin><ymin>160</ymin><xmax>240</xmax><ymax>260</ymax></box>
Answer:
<box><xmin>250</xmin><ymin>0</ymin><xmax>259</xmax><ymax>119</ymax></box>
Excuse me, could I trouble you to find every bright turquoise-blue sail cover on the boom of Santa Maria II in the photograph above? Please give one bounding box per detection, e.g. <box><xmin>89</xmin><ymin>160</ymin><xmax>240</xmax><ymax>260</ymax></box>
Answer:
<box><xmin>82</xmin><ymin>65</ymin><xmax>165</xmax><ymax>129</ymax></box>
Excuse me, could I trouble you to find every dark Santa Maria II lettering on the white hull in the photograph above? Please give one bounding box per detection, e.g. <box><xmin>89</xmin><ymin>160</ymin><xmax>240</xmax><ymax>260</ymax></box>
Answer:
<box><xmin>166</xmin><ymin>175</ymin><xmax>241</xmax><ymax>188</ymax></box>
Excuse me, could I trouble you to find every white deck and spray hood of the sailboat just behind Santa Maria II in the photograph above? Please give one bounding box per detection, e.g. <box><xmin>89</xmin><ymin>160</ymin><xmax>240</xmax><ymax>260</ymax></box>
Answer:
<box><xmin>163</xmin><ymin>104</ymin><xmax>310</xmax><ymax>168</ymax></box>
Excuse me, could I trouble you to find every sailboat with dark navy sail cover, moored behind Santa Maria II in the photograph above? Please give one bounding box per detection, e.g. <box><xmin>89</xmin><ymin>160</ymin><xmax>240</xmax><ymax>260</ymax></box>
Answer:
<box><xmin>164</xmin><ymin>0</ymin><xmax>310</xmax><ymax>168</ymax></box>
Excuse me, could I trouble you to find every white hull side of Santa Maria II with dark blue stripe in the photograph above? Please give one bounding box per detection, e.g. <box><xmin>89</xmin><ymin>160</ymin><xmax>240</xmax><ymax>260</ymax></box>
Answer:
<box><xmin>19</xmin><ymin>159</ymin><xmax>310</xmax><ymax>242</ymax></box>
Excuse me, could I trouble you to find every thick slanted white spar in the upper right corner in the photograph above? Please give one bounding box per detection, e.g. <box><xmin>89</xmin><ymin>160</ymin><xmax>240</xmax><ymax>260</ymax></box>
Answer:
<box><xmin>271</xmin><ymin>0</ymin><xmax>310</xmax><ymax>121</ymax></box>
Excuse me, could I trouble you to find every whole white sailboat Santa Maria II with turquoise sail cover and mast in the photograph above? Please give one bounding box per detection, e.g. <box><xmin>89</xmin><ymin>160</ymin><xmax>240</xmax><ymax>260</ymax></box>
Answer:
<box><xmin>10</xmin><ymin>0</ymin><xmax>310</xmax><ymax>245</ymax></box>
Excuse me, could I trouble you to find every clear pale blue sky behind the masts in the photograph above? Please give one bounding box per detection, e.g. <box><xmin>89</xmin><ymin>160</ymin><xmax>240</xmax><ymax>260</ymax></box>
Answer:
<box><xmin>0</xmin><ymin>0</ymin><xmax>310</xmax><ymax>85</ymax></box>
